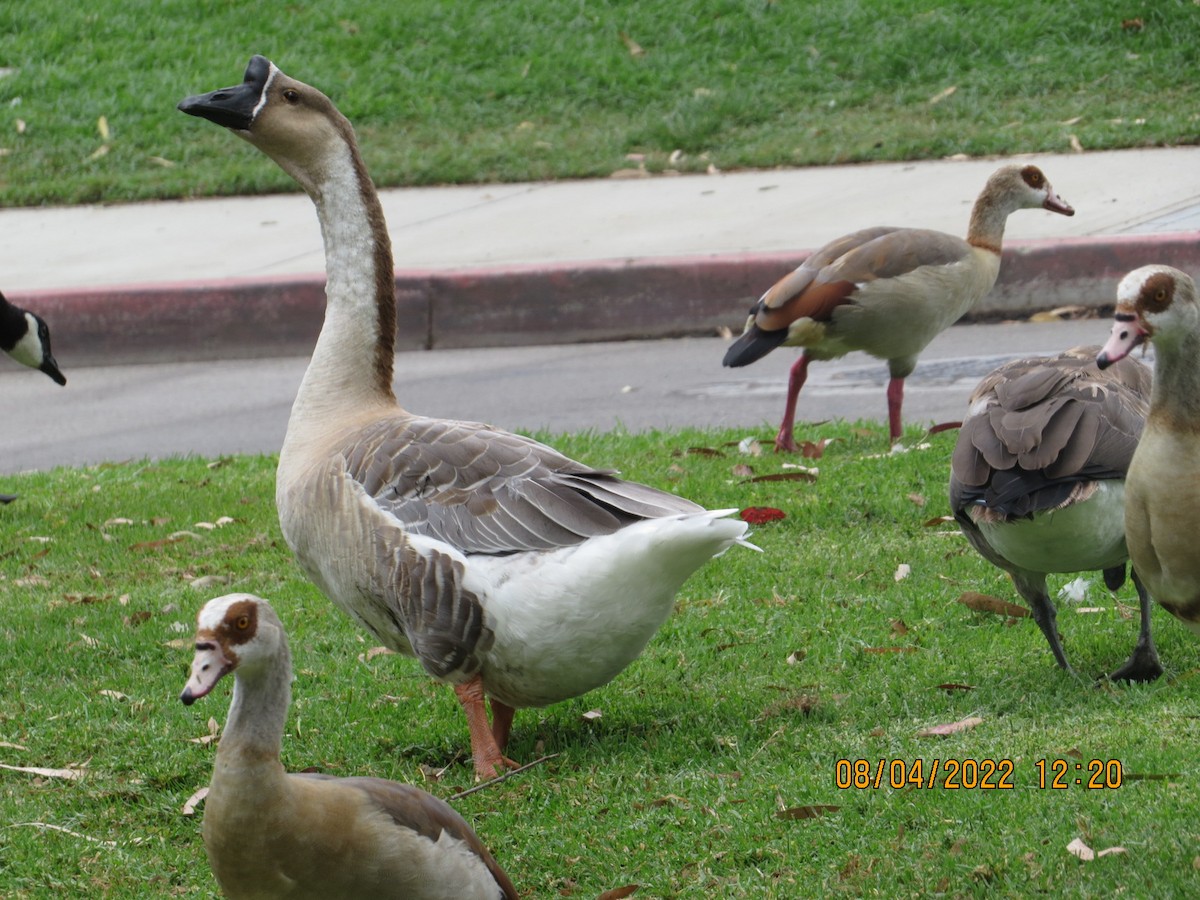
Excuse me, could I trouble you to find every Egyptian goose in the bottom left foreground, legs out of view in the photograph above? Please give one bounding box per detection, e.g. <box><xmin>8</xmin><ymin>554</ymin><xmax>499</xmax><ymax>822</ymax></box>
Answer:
<box><xmin>180</xmin><ymin>594</ymin><xmax>517</xmax><ymax>900</ymax></box>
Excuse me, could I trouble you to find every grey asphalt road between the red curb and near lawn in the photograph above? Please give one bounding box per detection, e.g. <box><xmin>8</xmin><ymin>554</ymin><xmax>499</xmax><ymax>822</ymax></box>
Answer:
<box><xmin>0</xmin><ymin>319</ymin><xmax>1123</xmax><ymax>473</ymax></box>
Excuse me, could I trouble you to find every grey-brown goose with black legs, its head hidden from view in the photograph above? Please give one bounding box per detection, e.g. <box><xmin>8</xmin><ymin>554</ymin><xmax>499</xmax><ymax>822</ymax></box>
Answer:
<box><xmin>950</xmin><ymin>347</ymin><xmax>1163</xmax><ymax>682</ymax></box>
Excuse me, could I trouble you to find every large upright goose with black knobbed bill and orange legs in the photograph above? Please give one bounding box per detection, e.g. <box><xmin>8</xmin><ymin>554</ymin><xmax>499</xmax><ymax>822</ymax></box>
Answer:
<box><xmin>179</xmin><ymin>56</ymin><xmax>749</xmax><ymax>778</ymax></box>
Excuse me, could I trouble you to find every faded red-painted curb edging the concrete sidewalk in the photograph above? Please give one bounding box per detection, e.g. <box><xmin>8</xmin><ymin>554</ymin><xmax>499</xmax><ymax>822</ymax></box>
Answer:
<box><xmin>10</xmin><ymin>232</ymin><xmax>1200</xmax><ymax>365</ymax></box>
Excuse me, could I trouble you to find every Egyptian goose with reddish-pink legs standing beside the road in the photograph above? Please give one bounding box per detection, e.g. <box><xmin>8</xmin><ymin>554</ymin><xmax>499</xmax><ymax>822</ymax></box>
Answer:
<box><xmin>724</xmin><ymin>166</ymin><xmax>1075</xmax><ymax>452</ymax></box>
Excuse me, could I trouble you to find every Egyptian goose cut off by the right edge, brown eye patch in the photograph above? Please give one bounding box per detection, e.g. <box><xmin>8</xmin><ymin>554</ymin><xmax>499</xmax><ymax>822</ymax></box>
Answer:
<box><xmin>1097</xmin><ymin>265</ymin><xmax>1200</xmax><ymax>634</ymax></box>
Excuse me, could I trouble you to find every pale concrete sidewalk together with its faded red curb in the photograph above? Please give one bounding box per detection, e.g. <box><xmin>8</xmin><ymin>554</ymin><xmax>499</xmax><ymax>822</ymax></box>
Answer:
<box><xmin>0</xmin><ymin>148</ymin><xmax>1200</xmax><ymax>365</ymax></box>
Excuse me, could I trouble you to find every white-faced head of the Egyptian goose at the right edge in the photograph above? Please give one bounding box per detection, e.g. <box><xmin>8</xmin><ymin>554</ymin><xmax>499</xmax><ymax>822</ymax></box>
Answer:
<box><xmin>1096</xmin><ymin>265</ymin><xmax>1200</xmax><ymax>368</ymax></box>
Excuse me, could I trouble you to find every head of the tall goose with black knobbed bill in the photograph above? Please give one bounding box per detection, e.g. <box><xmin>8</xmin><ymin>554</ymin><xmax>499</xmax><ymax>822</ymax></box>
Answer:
<box><xmin>178</xmin><ymin>55</ymin><xmax>355</xmax><ymax>197</ymax></box>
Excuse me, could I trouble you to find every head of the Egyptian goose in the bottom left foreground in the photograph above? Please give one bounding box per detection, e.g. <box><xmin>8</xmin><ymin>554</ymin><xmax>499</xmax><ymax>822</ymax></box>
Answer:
<box><xmin>179</xmin><ymin>594</ymin><xmax>287</xmax><ymax>706</ymax></box>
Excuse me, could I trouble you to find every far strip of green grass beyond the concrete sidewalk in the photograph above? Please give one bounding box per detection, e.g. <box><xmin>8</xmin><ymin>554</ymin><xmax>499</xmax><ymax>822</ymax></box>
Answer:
<box><xmin>0</xmin><ymin>0</ymin><xmax>1200</xmax><ymax>205</ymax></box>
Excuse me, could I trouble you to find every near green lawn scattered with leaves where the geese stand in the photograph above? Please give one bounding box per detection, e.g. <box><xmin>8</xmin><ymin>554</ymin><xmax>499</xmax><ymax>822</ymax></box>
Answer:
<box><xmin>0</xmin><ymin>424</ymin><xmax>1200</xmax><ymax>900</ymax></box>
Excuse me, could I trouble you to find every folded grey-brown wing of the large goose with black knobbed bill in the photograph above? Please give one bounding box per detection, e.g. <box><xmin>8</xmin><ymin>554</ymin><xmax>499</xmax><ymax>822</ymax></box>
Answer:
<box><xmin>347</xmin><ymin>414</ymin><xmax>703</xmax><ymax>553</ymax></box>
